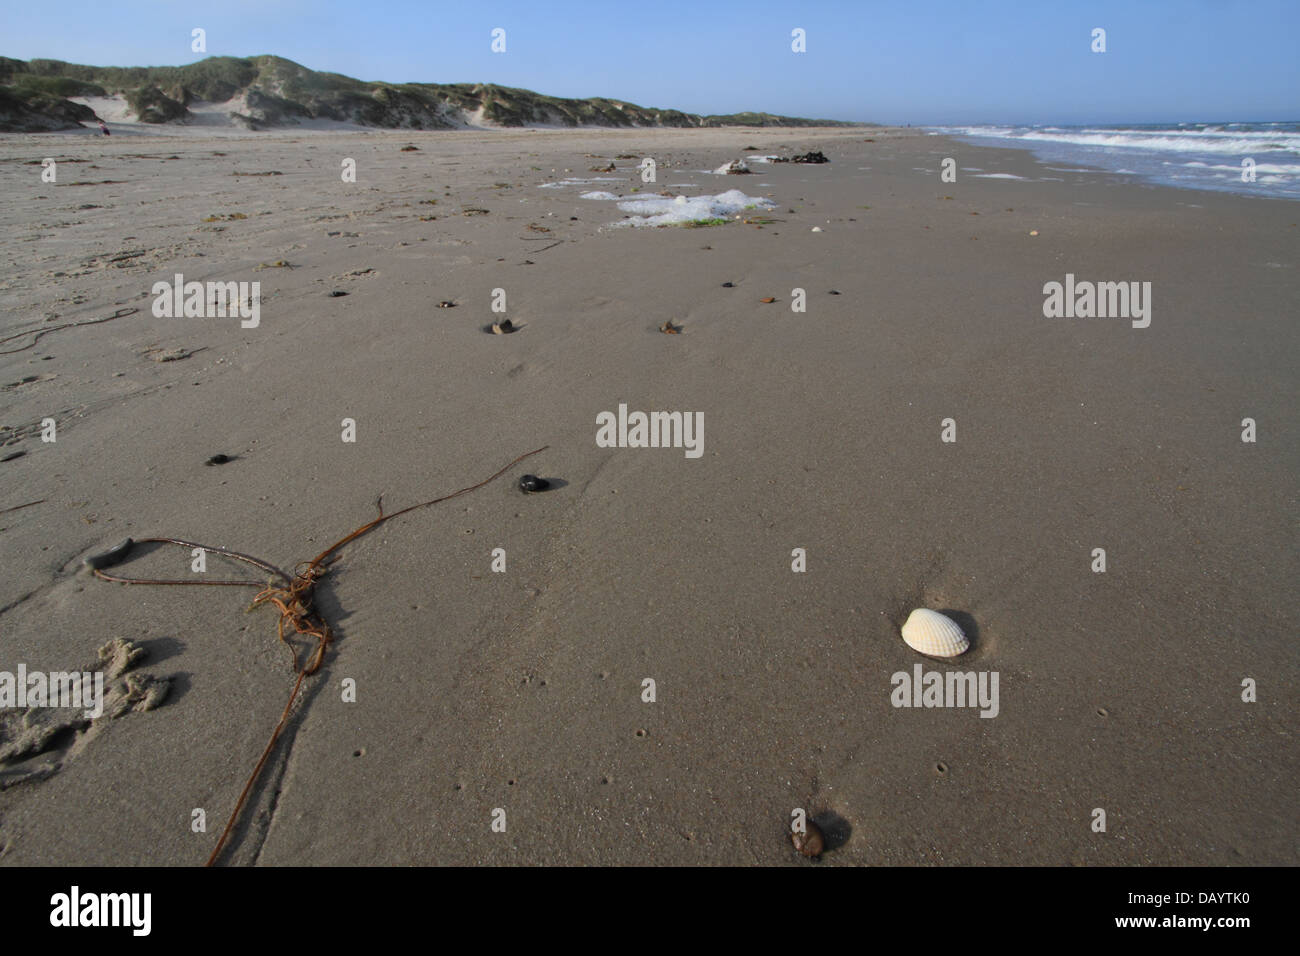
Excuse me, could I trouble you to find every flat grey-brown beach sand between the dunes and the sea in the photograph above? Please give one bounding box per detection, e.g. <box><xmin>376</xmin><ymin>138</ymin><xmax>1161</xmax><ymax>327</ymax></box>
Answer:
<box><xmin>0</xmin><ymin>121</ymin><xmax>1300</xmax><ymax>865</ymax></box>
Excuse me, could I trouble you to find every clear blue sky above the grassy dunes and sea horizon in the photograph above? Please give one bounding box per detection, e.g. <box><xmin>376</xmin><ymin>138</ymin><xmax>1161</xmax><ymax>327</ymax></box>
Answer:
<box><xmin>0</xmin><ymin>0</ymin><xmax>1300</xmax><ymax>125</ymax></box>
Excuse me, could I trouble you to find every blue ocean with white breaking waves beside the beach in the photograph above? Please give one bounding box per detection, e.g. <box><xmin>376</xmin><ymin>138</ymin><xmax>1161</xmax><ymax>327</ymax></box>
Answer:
<box><xmin>928</xmin><ymin>122</ymin><xmax>1300</xmax><ymax>199</ymax></box>
